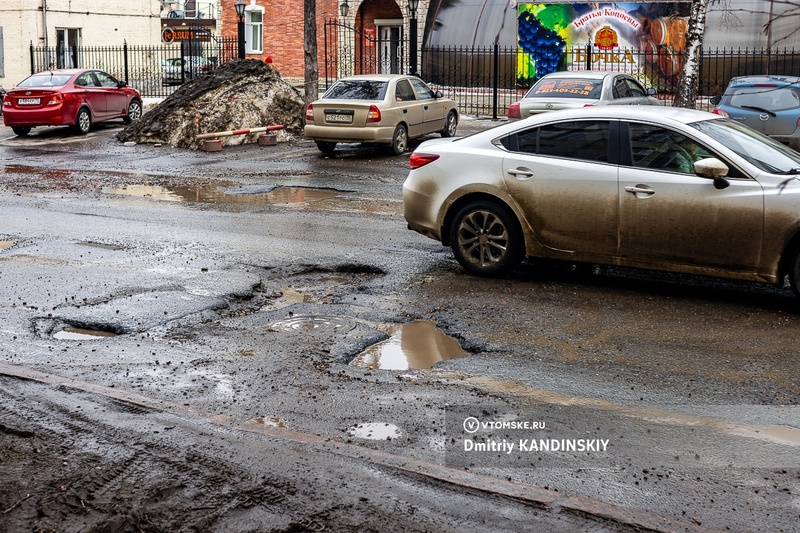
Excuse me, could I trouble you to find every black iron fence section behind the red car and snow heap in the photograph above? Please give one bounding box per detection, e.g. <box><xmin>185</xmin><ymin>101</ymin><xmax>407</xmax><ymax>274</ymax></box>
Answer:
<box><xmin>30</xmin><ymin>34</ymin><xmax>238</xmax><ymax>98</ymax></box>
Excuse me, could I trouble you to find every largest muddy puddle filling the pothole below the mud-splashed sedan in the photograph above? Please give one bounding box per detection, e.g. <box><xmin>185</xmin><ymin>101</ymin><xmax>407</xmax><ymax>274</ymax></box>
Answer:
<box><xmin>350</xmin><ymin>321</ymin><xmax>467</xmax><ymax>370</ymax></box>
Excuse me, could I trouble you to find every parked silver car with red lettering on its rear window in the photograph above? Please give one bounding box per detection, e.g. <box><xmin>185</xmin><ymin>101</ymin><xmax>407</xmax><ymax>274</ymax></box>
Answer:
<box><xmin>508</xmin><ymin>70</ymin><xmax>663</xmax><ymax>119</ymax></box>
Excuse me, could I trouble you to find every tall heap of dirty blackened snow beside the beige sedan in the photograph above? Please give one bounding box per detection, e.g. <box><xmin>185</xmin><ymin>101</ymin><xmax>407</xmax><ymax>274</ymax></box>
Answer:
<box><xmin>117</xmin><ymin>59</ymin><xmax>304</xmax><ymax>149</ymax></box>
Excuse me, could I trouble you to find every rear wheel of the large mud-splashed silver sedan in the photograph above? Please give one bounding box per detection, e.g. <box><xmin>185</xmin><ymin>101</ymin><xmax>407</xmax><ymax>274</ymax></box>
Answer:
<box><xmin>450</xmin><ymin>201</ymin><xmax>524</xmax><ymax>276</ymax></box>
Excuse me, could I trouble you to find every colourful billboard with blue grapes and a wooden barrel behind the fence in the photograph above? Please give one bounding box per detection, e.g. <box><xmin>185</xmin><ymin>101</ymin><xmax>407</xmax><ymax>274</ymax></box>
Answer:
<box><xmin>517</xmin><ymin>2</ymin><xmax>690</xmax><ymax>85</ymax></box>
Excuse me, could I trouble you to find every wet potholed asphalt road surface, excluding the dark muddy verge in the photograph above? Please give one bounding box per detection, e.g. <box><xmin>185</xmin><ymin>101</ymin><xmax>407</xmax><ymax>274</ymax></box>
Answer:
<box><xmin>0</xmin><ymin>120</ymin><xmax>800</xmax><ymax>531</ymax></box>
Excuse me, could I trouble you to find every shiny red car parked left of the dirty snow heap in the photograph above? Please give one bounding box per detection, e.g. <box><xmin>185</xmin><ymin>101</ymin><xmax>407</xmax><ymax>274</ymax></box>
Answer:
<box><xmin>3</xmin><ymin>69</ymin><xmax>142</xmax><ymax>136</ymax></box>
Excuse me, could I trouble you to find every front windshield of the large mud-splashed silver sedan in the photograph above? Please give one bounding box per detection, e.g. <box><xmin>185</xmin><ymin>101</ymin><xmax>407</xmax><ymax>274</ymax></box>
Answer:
<box><xmin>689</xmin><ymin>118</ymin><xmax>800</xmax><ymax>174</ymax></box>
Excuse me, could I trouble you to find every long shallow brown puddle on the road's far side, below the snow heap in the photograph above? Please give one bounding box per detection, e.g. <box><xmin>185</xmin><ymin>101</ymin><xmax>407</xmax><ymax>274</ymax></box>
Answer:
<box><xmin>101</xmin><ymin>185</ymin><xmax>339</xmax><ymax>205</ymax></box>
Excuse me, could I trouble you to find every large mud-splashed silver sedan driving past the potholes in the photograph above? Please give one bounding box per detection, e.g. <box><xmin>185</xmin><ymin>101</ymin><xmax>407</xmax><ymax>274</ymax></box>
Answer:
<box><xmin>403</xmin><ymin>106</ymin><xmax>800</xmax><ymax>296</ymax></box>
